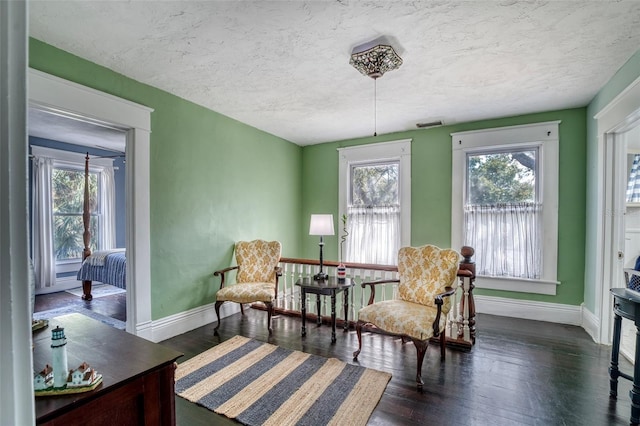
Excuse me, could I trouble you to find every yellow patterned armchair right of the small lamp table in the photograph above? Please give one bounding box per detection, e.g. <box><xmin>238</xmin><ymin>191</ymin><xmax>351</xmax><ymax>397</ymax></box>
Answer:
<box><xmin>353</xmin><ymin>245</ymin><xmax>460</xmax><ymax>389</ymax></box>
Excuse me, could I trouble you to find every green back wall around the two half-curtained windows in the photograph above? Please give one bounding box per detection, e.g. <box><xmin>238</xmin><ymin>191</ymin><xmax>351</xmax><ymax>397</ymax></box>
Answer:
<box><xmin>302</xmin><ymin>108</ymin><xmax>586</xmax><ymax>305</ymax></box>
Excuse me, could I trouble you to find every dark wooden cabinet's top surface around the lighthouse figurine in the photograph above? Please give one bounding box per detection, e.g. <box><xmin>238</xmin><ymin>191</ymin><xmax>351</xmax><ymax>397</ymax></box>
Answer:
<box><xmin>33</xmin><ymin>314</ymin><xmax>183</xmax><ymax>419</ymax></box>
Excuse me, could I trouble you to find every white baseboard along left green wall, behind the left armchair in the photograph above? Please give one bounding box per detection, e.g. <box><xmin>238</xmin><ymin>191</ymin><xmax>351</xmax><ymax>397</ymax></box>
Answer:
<box><xmin>145</xmin><ymin>303</ymin><xmax>240</xmax><ymax>342</ymax></box>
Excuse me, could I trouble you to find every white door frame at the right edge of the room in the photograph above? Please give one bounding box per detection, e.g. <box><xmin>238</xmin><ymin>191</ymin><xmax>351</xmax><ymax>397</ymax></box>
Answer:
<box><xmin>594</xmin><ymin>77</ymin><xmax>640</xmax><ymax>344</ymax></box>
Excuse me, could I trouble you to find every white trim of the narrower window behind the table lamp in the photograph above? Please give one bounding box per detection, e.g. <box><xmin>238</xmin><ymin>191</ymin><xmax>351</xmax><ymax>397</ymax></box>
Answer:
<box><xmin>338</xmin><ymin>139</ymin><xmax>411</xmax><ymax>256</ymax></box>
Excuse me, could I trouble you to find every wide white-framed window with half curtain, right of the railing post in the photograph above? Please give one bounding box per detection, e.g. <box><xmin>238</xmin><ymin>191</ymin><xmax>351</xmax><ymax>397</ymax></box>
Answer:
<box><xmin>452</xmin><ymin>122</ymin><xmax>559</xmax><ymax>294</ymax></box>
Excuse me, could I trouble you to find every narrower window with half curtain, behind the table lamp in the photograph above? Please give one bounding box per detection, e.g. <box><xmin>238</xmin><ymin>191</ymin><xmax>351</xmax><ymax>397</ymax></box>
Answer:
<box><xmin>338</xmin><ymin>140</ymin><xmax>411</xmax><ymax>265</ymax></box>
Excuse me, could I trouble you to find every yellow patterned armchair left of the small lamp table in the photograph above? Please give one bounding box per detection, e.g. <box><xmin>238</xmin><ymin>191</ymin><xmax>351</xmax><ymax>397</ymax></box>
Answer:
<box><xmin>213</xmin><ymin>240</ymin><xmax>282</xmax><ymax>334</ymax></box>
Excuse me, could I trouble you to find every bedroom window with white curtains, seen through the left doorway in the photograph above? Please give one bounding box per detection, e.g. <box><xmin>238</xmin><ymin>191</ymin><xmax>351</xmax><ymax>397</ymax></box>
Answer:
<box><xmin>31</xmin><ymin>146</ymin><xmax>115</xmax><ymax>288</ymax></box>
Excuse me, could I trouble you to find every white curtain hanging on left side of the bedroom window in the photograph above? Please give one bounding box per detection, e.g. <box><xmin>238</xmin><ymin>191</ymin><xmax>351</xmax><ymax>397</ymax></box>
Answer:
<box><xmin>32</xmin><ymin>157</ymin><xmax>56</xmax><ymax>288</ymax></box>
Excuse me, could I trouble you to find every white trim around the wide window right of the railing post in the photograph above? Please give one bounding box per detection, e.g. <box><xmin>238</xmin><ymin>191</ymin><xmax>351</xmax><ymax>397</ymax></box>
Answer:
<box><xmin>451</xmin><ymin>121</ymin><xmax>560</xmax><ymax>295</ymax></box>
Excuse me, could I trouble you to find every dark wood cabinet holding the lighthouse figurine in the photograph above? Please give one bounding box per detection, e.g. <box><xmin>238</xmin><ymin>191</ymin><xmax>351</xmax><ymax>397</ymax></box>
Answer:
<box><xmin>33</xmin><ymin>314</ymin><xmax>182</xmax><ymax>426</ymax></box>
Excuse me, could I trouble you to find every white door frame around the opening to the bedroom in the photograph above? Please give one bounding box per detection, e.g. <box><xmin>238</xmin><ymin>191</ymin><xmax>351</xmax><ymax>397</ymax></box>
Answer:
<box><xmin>28</xmin><ymin>68</ymin><xmax>153</xmax><ymax>340</ymax></box>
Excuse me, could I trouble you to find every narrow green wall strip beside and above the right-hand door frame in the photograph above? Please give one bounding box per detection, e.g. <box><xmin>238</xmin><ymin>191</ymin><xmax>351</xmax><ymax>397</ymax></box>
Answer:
<box><xmin>584</xmin><ymin>50</ymin><xmax>640</xmax><ymax>313</ymax></box>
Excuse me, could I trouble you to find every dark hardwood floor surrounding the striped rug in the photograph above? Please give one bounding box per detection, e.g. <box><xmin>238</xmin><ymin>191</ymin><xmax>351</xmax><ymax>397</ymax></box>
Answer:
<box><xmin>33</xmin><ymin>292</ymin><xmax>633</xmax><ymax>426</ymax></box>
